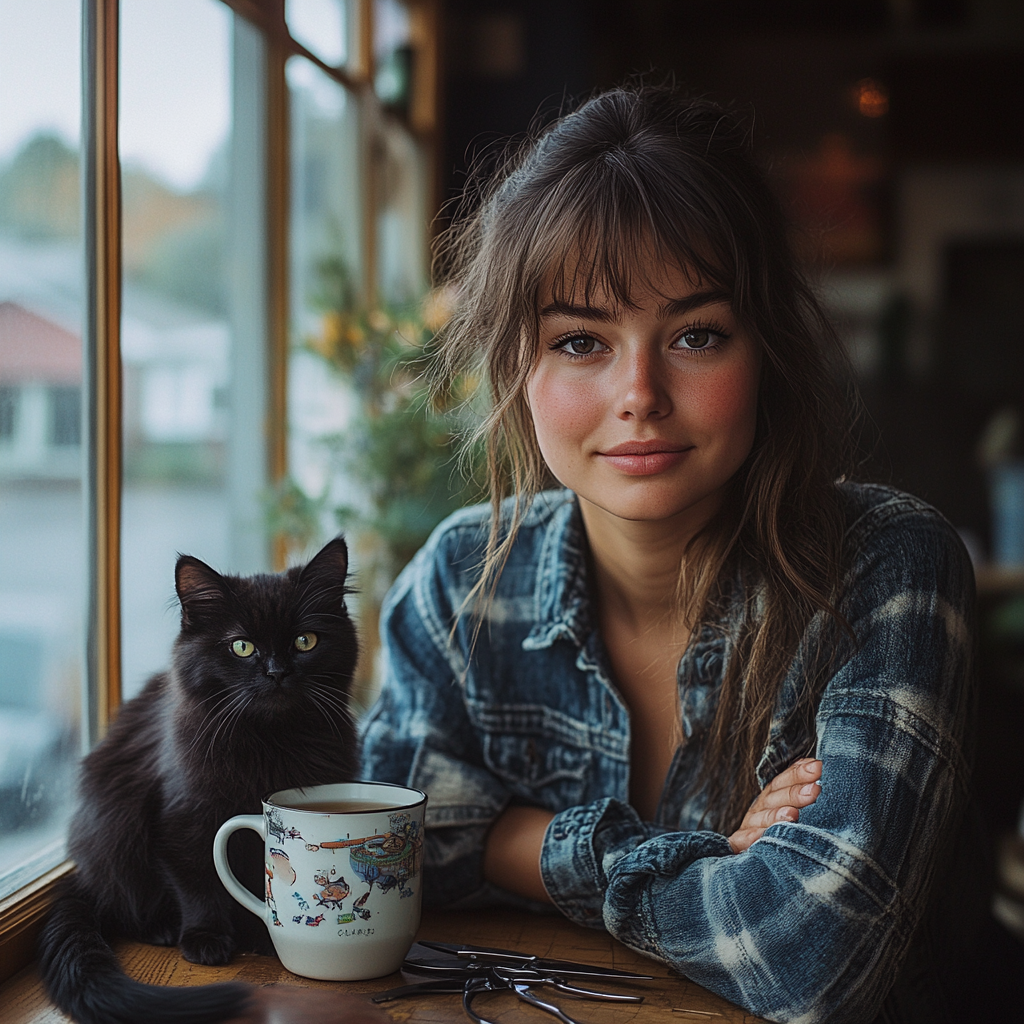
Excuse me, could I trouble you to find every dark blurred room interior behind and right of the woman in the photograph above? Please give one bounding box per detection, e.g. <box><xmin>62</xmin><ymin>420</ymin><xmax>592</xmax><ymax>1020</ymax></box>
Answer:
<box><xmin>439</xmin><ymin>0</ymin><xmax>1024</xmax><ymax>991</ymax></box>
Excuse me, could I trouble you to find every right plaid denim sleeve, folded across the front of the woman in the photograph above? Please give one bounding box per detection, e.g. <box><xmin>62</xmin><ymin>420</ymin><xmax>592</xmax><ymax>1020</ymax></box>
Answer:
<box><xmin>541</xmin><ymin>503</ymin><xmax>974</xmax><ymax>1022</ymax></box>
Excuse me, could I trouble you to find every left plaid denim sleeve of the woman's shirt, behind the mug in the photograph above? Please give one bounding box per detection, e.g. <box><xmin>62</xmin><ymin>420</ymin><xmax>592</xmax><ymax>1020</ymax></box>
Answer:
<box><xmin>360</xmin><ymin>535</ymin><xmax>520</xmax><ymax>906</ymax></box>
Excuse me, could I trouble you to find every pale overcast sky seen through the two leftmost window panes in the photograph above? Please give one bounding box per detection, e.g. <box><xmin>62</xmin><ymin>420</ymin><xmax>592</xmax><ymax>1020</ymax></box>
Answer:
<box><xmin>0</xmin><ymin>0</ymin><xmax>231</xmax><ymax>189</ymax></box>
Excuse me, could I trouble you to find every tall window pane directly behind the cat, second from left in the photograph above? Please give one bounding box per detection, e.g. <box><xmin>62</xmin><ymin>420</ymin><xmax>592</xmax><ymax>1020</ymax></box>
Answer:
<box><xmin>120</xmin><ymin>0</ymin><xmax>234</xmax><ymax>698</ymax></box>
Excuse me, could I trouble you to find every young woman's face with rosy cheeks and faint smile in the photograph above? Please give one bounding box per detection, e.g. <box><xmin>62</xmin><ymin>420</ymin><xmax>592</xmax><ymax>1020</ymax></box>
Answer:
<box><xmin>526</xmin><ymin>264</ymin><xmax>761</xmax><ymax>531</ymax></box>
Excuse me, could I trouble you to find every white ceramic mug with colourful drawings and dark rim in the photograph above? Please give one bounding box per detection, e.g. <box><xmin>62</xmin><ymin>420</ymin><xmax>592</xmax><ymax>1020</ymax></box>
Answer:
<box><xmin>213</xmin><ymin>782</ymin><xmax>427</xmax><ymax>981</ymax></box>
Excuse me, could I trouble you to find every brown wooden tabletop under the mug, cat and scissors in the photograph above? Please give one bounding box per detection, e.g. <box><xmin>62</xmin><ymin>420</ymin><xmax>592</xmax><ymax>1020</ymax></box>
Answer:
<box><xmin>0</xmin><ymin>910</ymin><xmax>760</xmax><ymax>1024</ymax></box>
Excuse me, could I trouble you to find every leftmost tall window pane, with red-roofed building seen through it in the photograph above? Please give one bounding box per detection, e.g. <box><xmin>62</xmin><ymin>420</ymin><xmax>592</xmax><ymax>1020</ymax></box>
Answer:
<box><xmin>0</xmin><ymin>0</ymin><xmax>86</xmax><ymax>896</ymax></box>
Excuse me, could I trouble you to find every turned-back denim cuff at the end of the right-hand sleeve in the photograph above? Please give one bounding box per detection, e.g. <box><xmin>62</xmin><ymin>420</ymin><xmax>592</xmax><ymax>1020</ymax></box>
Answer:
<box><xmin>541</xmin><ymin>798</ymin><xmax>663</xmax><ymax>928</ymax></box>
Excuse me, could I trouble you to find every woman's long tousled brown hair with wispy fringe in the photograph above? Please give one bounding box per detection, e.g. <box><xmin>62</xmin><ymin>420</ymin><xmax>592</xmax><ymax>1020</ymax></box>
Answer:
<box><xmin>435</xmin><ymin>84</ymin><xmax>852</xmax><ymax>831</ymax></box>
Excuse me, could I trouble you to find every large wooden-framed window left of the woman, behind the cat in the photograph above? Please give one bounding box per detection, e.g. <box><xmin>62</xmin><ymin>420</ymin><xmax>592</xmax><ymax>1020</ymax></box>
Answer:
<box><xmin>0</xmin><ymin>0</ymin><xmax>434</xmax><ymax>978</ymax></box>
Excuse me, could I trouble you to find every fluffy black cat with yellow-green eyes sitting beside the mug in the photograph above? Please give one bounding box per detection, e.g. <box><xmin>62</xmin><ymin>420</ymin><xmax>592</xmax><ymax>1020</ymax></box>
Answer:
<box><xmin>40</xmin><ymin>538</ymin><xmax>368</xmax><ymax>1024</ymax></box>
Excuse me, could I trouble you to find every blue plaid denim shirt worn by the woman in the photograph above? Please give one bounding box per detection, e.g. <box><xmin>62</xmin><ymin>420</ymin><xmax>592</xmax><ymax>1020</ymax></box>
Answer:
<box><xmin>361</xmin><ymin>484</ymin><xmax>974</xmax><ymax>1022</ymax></box>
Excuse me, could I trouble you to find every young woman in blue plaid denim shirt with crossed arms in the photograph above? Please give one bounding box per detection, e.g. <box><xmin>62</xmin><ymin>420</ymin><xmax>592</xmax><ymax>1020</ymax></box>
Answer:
<box><xmin>364</xmin><ymin>87</ymin><xmax>976</xmax><ymax>1022</ymax></box>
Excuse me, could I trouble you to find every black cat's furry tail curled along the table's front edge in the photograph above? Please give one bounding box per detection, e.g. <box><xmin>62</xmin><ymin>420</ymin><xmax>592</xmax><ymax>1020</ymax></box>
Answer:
<box><xmin>39</xmin><ymin>877</ymin><xmax>253</xmax><ymax>1024</ymax></box>
